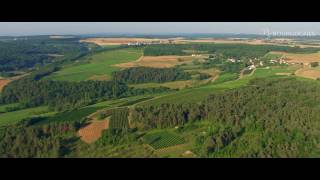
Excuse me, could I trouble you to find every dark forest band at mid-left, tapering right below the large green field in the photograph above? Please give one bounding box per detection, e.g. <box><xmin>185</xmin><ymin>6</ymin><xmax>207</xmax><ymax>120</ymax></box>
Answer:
<box><xmin>0</xmin><ymin>72</ymin><xmax>176</xmax><ymax>111</ymax></box>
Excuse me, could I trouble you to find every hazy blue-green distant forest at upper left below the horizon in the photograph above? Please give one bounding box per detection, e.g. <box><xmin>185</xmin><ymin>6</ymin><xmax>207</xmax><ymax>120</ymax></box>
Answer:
<box><xmin>0</xmin><ymin>37</ymin><xmax>92</xmax><ymax>76</ymax></box>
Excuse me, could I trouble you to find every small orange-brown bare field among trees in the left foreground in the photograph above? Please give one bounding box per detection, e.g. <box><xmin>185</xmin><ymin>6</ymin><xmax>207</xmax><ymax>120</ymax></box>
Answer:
<box><xmin>78</xmin><ymin>119</ymin><xmax>109</xmax><ymax>143</ymax></box>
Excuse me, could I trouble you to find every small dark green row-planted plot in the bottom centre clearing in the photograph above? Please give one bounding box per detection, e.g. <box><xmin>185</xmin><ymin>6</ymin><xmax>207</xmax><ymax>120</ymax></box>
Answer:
<box><xmin>143</xmin><ymin>131</ymin><xmax>185</xmax><ymax>150</ymax></box>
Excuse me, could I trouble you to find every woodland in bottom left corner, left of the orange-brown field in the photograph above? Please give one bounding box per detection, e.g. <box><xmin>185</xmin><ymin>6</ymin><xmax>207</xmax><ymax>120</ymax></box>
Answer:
<box><xmin>0</xmin><ymin>119</ymin><xmax>79</xmax><ymax>158</ymax></box>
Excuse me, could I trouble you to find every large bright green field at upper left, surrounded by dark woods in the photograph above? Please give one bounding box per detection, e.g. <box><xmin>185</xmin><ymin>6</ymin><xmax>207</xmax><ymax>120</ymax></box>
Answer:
<box><xmin>49</xmin><ymin>48</ymin><xmax>142</xmax><ymax>81</ymax></box>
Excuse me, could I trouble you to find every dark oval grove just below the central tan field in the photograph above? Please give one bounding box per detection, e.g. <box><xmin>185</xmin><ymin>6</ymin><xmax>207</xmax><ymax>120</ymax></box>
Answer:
<box><xmin>113</xmin><ymin>67</ymin><xmax>191</xmax><ymax>84</ymax></box>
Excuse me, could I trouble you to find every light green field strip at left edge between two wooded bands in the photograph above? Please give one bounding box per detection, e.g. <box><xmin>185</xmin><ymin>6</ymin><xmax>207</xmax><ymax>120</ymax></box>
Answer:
<box><xmin>0</xmin><ymin>106</ymin><xmax>48</xmax><ymax>127</ymax></box>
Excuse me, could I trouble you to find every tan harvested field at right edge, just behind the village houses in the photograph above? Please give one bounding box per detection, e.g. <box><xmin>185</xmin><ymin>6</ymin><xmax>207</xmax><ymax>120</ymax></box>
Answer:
<box><xmin>270</xmin><ymin>51</ymin><xmax>320</xmax><ymax>65</ymax></box>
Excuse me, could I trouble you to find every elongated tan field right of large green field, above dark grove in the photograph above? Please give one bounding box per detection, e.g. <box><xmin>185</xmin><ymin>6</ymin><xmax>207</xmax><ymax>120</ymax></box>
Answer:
<box><xmin>114</xmin><ymin>56</ymin><xmax>199</xmax><ymax>68</ymax></box>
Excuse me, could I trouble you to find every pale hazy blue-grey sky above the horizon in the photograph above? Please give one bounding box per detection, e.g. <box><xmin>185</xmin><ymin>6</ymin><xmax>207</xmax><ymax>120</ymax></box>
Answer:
<box><xmin>0</xmin><ymin>22</ymin><xmax>320</xmax><ymax>36</ymax></box>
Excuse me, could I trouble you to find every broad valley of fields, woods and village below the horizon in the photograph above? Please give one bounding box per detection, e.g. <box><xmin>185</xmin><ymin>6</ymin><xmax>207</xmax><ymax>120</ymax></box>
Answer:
<box><xmin>0</xmin><ymin>34</ymin><xmax>320</xmax><ymax>158</ymax></box>
